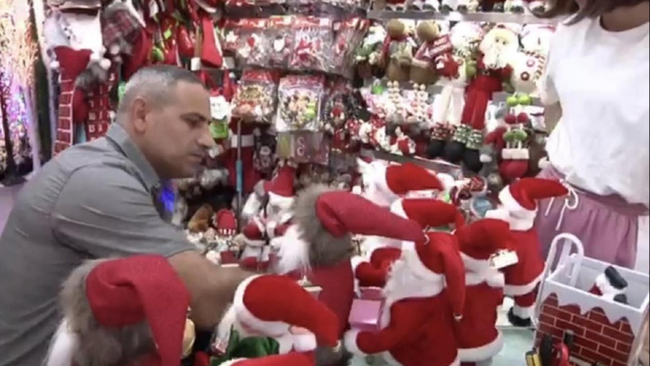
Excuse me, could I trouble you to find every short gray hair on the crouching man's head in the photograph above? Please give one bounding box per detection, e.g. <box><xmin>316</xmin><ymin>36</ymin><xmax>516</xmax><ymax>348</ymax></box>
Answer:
<box><xmin>117</xmin><ymin>65</ymin><xmax>203</xmax><ymax>116</ymax></box>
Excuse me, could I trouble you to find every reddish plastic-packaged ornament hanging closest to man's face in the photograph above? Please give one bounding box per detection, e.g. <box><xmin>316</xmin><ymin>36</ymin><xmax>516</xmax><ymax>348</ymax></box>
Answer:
<box><xmin>232</xmin><ymin>70</ymin><xmax>279</xmax><ymax>123</ymax></box>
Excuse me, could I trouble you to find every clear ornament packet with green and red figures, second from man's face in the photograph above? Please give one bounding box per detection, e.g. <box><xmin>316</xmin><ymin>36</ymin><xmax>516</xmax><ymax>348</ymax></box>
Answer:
<box><xmin>275</xmin><ymin>75</ymin><xmax>325</xmax><ymax>132</ymax></box>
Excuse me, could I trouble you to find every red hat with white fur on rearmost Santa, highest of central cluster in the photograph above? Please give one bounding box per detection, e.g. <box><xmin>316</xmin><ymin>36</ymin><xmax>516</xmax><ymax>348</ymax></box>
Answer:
<box><xmin>357</xmin><ymin>159</ymin><xmax>445</xmax><ymax>207</ymax></box>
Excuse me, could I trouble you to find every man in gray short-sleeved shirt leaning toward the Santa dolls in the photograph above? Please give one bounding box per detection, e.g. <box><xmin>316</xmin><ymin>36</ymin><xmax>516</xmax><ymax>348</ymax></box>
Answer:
<box><xmin>0</xmin><ymin>66</ymin><xmax>248</xmax><ymax>366</ymax></box>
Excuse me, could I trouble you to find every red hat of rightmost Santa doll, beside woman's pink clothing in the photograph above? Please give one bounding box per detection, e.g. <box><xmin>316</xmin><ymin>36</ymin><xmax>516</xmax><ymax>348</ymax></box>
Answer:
<box><xmin>499</xmin><ymin>178</ymin><xmax>569</xmax><ymax>213</ymax></box>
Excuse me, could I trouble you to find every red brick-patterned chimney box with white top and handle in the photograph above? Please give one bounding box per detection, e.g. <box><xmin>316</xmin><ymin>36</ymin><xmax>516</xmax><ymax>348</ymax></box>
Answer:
<box><xmin>535</xmin><ymin>235</ymin><xmax>650</xmax><ymax>366</ymax></box>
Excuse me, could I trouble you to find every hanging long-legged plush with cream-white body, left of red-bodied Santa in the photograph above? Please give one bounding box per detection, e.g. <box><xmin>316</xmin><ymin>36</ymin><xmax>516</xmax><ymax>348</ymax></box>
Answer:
<box><xmin>427</xmin><ymin>22</ymin><xmax>484</xmax><ymax>159</ymax></box>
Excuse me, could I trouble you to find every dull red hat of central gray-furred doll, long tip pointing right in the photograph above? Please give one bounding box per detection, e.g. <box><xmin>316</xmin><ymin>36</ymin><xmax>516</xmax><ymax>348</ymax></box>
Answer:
<box><xmin>316</xmin><ymin>191</ymin><xmax>424</xmax><ymax>241</ymax></box>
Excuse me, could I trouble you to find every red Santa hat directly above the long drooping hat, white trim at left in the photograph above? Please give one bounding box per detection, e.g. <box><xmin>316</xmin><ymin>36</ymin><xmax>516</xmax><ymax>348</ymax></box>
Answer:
<box><xmin>391</xmin><ymin>198</ymin><xmax>465</xmax><ymax>229</ymax></box>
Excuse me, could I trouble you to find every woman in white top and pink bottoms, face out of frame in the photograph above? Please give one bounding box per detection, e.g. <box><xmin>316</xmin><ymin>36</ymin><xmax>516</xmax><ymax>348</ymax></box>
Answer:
<box><xmin>536</xmin><ymin>0</ymin><xmax>650</xmax><ymax>267</ymax></box>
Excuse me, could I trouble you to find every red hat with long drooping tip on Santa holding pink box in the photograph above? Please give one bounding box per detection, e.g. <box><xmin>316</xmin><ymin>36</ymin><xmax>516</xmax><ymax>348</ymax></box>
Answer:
<box><xmin>403</xmin><ymin>232</ymin><xmax>466</xmax><ymax>318</ymax></box>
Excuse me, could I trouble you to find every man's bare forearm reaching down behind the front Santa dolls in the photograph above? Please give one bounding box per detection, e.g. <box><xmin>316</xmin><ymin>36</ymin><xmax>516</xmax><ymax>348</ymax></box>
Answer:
<box><xmin>169</xmin><ymin>252</ymin><xmax>253</xmax><ymax>330</ymax></box>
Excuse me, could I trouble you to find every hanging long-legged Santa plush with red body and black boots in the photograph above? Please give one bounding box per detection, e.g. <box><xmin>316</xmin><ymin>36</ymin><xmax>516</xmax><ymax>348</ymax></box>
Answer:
<box><xmin>445</xmin><ymin>26</ymin><xmax>519</xmax><ymax>172</ymax></box>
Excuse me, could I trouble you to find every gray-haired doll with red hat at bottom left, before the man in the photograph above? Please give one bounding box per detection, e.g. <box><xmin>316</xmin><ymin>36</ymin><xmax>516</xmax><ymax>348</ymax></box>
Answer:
<box><xmin>46</xmin><ymin>256</ymin><xmax>190</xmax><ymax>366</ymax></box>
